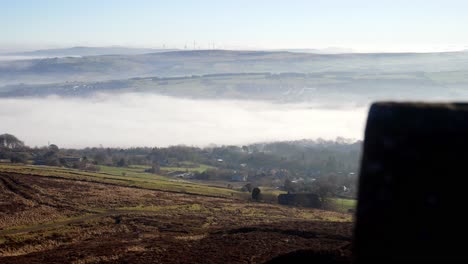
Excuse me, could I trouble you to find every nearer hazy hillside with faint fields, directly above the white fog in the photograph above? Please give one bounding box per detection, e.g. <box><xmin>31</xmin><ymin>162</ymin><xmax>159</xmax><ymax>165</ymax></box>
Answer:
<box><xmin>0</xmin><ymin>71</ymin><xmax>468</xmax><ymax>107</ymax></box>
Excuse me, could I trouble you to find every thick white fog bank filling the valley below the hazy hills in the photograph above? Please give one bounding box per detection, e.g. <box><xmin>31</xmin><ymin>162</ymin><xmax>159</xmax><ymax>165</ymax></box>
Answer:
<box><xmin>0</xmin><ymin>94</ymin><xmax>367</xmax><ymax>148</ymax></box>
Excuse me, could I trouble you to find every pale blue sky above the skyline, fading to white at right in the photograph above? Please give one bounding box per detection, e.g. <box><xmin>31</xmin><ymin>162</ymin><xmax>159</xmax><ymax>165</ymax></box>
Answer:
<box><xmin>0</xmin><ymin>0</ymin><xmax>468</xmax><ymax>51</ymax></box>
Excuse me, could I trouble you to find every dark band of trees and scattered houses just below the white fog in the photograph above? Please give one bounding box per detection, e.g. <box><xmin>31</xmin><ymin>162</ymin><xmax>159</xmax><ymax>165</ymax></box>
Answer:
<box><xmin>0</xmin><ymin>134</ymin><xmax>362</xmax><ymax>198</ymax></box>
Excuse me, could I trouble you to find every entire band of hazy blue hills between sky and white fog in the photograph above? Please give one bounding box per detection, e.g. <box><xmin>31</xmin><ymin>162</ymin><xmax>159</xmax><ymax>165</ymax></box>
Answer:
<box><xmin>0</xmin><ymin>50</ymin><xmax>468</xmax><ymax>106</ymax></box>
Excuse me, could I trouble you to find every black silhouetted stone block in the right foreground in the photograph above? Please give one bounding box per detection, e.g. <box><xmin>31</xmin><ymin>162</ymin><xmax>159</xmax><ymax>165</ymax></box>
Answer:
<box><xmin>354</xmin><ymin>103</ymin><xmax>468</xmax><ymax>263</ymax></box>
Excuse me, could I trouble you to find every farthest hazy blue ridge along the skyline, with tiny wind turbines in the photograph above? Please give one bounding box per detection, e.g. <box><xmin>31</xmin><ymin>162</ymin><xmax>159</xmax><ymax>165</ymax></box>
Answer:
<box><xmin>0</xmin><ymin>50</ymin><xmax>468</xmax><ymax>86</ymax></box>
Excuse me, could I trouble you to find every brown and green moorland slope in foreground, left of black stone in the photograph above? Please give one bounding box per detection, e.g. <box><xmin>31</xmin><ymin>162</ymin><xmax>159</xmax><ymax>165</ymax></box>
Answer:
<box><xmin>0</xmin><ymin>165</ymin><xmax>352</xmax><ymax>263</ymax></box>
